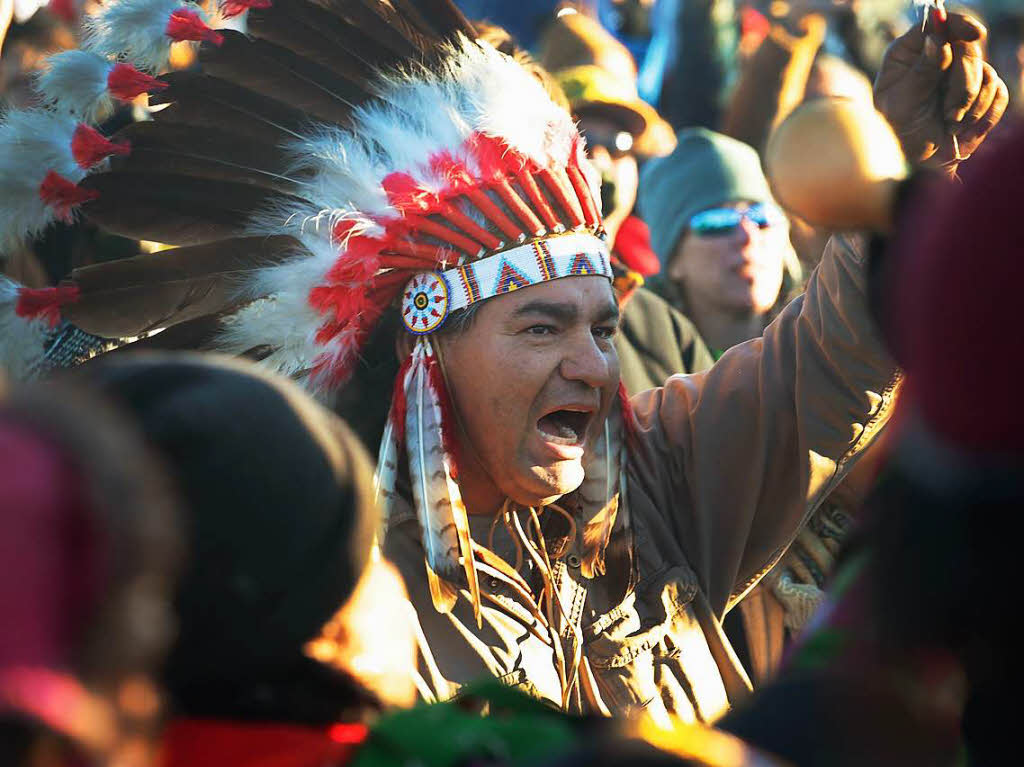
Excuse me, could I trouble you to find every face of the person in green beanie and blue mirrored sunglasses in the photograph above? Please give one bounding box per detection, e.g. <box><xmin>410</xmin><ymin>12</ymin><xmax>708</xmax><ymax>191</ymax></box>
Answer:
<box><xmin>668</xmin><ymin>203</ymin><xmax>790</xmax><ymax>314</ymax></box>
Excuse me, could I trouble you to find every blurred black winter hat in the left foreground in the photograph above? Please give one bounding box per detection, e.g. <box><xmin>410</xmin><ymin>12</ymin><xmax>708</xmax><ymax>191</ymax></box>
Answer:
<box><xmin>69</xmin><ymin>354</ymin><xmax>377</xmax><ymax>697</ymax></box>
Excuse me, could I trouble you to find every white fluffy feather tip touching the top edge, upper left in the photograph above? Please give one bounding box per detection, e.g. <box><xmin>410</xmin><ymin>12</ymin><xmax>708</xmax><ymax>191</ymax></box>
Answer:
<box><xmin>83</xmin><ymin>0</ymin><xmax>206</xmax><ymax>72</ymax></box>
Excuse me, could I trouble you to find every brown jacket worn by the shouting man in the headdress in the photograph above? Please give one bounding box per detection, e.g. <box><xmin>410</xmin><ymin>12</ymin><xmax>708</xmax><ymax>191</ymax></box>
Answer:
<box><xmin>384</xmin><ymin>231</ymin><xmax>898</xmax><ymax>721</ymax></box>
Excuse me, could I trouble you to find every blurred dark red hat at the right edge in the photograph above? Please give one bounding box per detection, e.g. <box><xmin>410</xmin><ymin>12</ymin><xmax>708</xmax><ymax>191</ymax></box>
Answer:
<box><xmin>885</xmin><ymin>129</ymin><xmax>1024</xmax><ymax>454</ymax></box>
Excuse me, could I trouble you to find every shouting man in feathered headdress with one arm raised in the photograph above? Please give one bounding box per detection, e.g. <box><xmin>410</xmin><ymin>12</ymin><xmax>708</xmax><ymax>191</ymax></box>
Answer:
<box><xmin>0</xmin><ymin>0</ymin><xmax>1005</xmax><ymax>720</ymax></box>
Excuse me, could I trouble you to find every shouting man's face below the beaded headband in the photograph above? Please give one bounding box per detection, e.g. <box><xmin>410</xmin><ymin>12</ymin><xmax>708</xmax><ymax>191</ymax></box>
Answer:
<box><xmin>440</xmin><ymin>276</ymin><xmax>618</xmax><ymax>513</ymax></box>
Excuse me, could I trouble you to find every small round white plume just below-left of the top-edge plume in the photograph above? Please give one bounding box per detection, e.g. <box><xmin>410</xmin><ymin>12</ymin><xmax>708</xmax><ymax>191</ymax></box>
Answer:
<box><xmin>36</xmin><ymin>49</ymin><xmax>114</xmax><ymax>123</ymax></box>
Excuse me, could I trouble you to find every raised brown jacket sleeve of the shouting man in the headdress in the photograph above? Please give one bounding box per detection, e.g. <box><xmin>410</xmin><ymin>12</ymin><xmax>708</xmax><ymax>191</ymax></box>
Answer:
<box><xmin>631</xmin><ymin>238</ymin><xmax>899</xmax><ymax>614</ymax></box>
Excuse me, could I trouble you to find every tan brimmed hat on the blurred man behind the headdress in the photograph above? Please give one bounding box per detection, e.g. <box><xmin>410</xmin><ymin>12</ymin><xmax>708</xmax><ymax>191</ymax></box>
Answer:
<box><xmin>540</xmin><ymin>11</ymin><xmax>676</xmax><ymax>157</ymax></box>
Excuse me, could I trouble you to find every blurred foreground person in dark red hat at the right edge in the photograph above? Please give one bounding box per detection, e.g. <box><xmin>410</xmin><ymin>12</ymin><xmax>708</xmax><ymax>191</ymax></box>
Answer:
<box><xmin>723</xmin><ymin>118</ymin><xmax>1024</xmax><ymax>767</ymax></box>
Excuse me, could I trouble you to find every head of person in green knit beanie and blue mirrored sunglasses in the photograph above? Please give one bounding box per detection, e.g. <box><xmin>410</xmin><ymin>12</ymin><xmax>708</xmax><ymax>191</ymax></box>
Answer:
<box><xmin>638</xmin><ymin>128</ymin><xmax>799</xmax><ymax>356</ymax></box>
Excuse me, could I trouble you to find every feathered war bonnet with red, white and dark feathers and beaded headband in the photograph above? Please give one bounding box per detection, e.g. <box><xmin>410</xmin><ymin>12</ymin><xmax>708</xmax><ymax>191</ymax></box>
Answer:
<box><xmin>0</xmin><ymin>0</ymin><xmax>626</xmax><ymax>621</ymax></box>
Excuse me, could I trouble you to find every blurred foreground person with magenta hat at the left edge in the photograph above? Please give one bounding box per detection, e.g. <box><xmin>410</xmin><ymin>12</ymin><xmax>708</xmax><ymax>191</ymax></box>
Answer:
<box><xmin>0</xmin><ymin>384</ymin><xmax>180</xmax><ymax>767</ymax></box>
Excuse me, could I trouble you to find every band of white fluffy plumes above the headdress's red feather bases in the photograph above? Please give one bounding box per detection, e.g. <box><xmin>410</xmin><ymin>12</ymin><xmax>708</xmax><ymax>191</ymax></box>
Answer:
<box><xmin>224</xmin><ymin>39</ymin><xmax>577</xmax><ymax>380</ymax></box>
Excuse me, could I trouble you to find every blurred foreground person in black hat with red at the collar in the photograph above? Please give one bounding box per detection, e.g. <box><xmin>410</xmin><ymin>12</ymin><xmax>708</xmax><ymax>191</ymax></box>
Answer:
<box><xmin>70</xmin><ymin>354</ymin><xmax>416</xmax><ymax>767</ymax></box>
